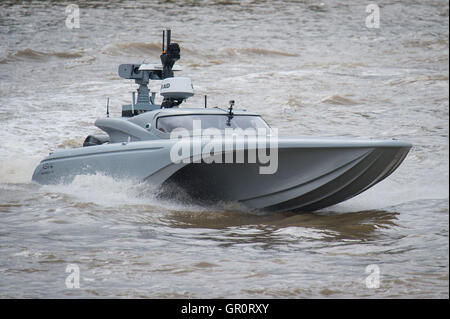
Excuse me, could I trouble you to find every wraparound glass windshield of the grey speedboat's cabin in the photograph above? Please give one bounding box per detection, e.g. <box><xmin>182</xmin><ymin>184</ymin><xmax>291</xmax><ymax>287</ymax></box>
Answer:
<box><xmin>156</xmin><ymin>114</ymin><xmax>270</xmax><ymax>133</ymax></box>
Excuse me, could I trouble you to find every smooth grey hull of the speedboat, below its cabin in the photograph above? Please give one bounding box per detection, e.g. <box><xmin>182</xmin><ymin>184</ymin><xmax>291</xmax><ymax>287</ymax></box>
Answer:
<box><xmin>33</xmin><ymin>138</ymin><xmax>411</xmax><ymax>212</ymax></box>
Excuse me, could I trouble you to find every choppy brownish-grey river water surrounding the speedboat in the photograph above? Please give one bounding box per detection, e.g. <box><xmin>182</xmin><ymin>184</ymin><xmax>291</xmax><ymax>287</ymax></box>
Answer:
<box><xmin>0</xmin><ymin>0</ymin><xmax>449</xmax><ymax>298</ymax></box>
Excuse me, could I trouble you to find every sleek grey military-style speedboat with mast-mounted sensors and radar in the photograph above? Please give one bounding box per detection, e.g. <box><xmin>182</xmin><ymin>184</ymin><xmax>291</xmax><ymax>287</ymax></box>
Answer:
<box><xmin>32</xmin><ymin>30</ymin><xmax>412</xmax><ymax>212</ymax></box>
